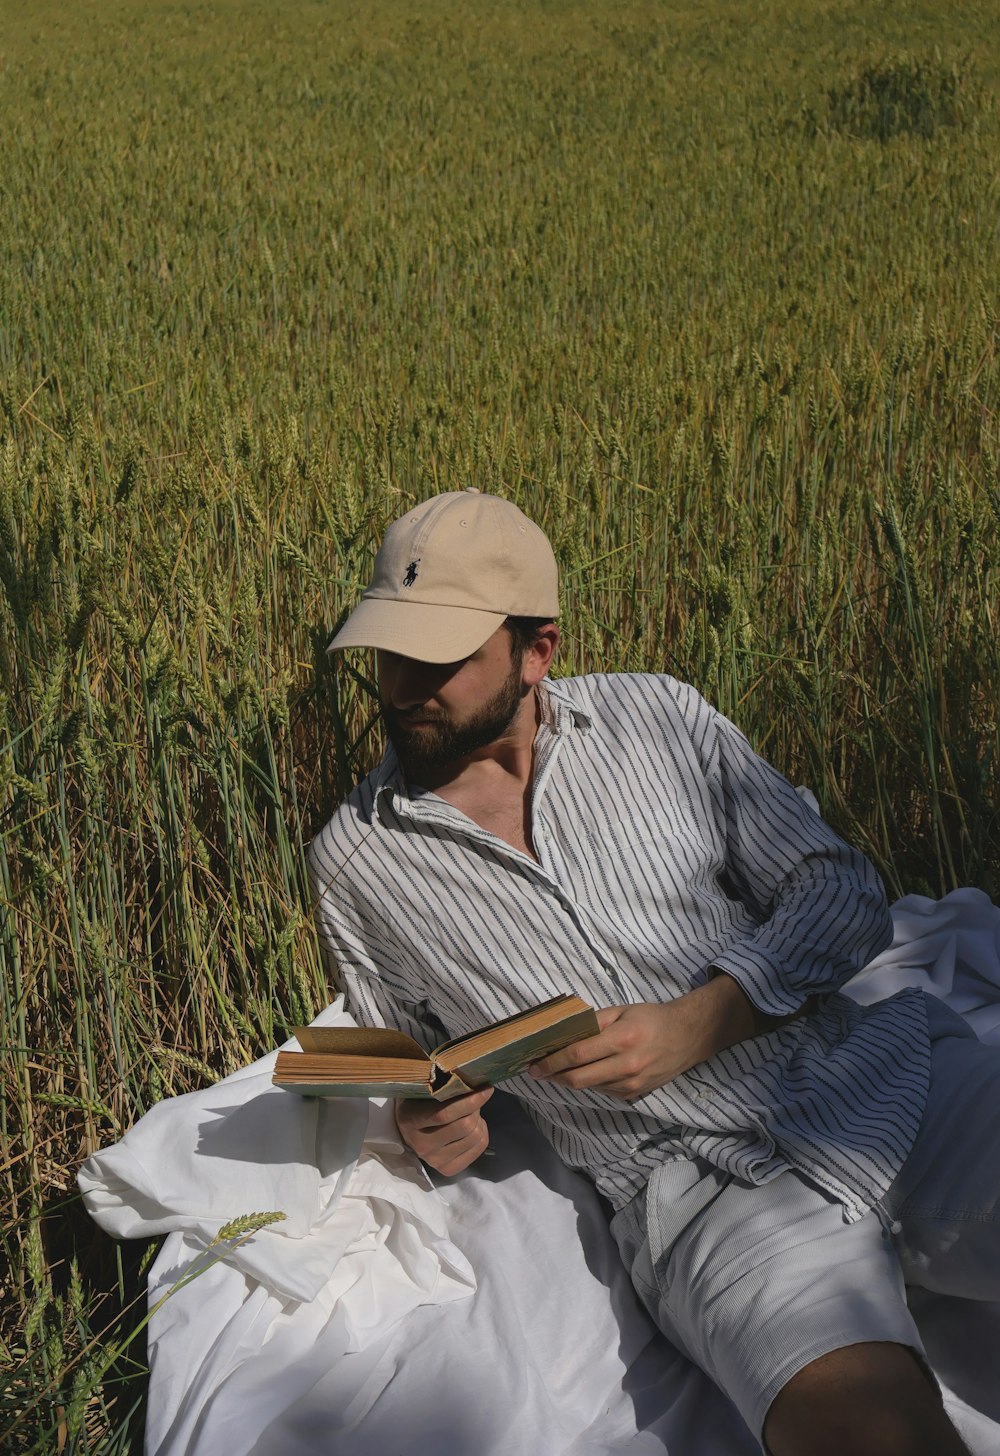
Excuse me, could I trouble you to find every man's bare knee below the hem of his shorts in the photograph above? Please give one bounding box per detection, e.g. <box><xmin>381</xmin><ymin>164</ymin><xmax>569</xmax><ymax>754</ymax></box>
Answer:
<box><xmin>764</xmin><ymin>1344</ymin><xmax>968</xmax><ymax>1456</ymax></box>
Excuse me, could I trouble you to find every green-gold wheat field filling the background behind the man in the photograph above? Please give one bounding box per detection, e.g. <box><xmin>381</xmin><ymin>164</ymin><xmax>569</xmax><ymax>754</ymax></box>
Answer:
<box><xmin>0</xmin><ymin>0</ymin><xmax>1000</xmax><ymax>1452</ymax></box>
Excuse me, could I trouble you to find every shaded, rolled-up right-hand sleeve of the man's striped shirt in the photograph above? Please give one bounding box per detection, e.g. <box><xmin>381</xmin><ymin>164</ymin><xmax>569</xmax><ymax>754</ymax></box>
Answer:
<box><xmin>692</xmin><ymin>695</ymin><xmax>892</xmax><ymax>1016</ymax></box>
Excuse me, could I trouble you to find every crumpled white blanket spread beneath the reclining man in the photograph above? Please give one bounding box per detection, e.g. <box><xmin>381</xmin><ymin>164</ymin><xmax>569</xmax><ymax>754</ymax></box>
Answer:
<box><xmin>80</xmin><ymin>890</ymin><xmax>1000</xmax><ymax>1456</ymax></box>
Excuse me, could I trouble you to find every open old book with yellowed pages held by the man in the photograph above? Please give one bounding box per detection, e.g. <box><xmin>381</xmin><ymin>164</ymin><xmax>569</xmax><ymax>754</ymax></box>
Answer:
<box><xmin>274</xmin><ymin>994</ymin><xmax>598</xmax><ymax>1102</ymax></box>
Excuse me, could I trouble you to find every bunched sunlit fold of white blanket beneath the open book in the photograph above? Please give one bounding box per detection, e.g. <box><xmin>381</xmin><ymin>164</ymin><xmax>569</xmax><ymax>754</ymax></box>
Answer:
<box><xmin>79</xmin><ymin>997</ymin><xmax>476</xmax><ymax>1342</ymax></box>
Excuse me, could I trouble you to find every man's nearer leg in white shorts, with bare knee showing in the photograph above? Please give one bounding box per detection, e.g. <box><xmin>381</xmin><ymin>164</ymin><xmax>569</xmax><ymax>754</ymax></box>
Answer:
<box><xmin>611</xmin><ymin>1162</ymin><xmax>965</xmax><ymax>1456</ymax></box>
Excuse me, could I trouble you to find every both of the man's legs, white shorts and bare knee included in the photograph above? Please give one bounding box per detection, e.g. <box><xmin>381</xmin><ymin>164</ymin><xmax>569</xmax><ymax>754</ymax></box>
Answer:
<box><xmin>613</xmin><ymin>999</ymin><xmax>1000</xmax><ymax>1456</ymax></box>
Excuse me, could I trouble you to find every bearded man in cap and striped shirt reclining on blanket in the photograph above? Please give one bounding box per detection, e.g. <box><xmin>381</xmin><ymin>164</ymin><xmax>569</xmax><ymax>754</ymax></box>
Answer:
<box><xmin>311</xmin><ymin>491</ymin><xmax>1000</xmax><ymax>1456</ymax></box>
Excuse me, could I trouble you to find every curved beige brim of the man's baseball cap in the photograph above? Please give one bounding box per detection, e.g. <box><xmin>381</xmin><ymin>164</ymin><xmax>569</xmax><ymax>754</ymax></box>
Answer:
<box><xmin>326</xmin><ymin>597</ymin><xmax>507</xmax><ymax>662</ymax></box>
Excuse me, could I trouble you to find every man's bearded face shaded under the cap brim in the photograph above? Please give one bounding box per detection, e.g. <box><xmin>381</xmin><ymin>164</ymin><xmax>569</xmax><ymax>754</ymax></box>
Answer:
<box><xmin>377</xmin><ymin>628</ymin><xmax>525</xmax><ymax>783</ymax></box>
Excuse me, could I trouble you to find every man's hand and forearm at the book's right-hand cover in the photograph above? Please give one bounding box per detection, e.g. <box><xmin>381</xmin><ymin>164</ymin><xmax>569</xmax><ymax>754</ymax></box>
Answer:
<box><xmin>528</xmin><ymin>974</ymin><xmax>763</xmax><ymax>1102</ymax></box>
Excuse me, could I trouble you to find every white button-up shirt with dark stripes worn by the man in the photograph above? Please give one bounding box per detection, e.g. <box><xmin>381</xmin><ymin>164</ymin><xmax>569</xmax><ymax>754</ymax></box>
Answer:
<box><xmin>310</xmin><ymin>674</ymin><xmax>930</xmax><ymax>1220</ymax></box>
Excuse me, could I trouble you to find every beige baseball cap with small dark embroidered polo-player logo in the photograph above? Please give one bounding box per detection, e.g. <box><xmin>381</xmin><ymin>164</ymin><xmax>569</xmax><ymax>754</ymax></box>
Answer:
<box><xmin>326</xmin><ymin>489</ymin><xmax>559</xmax><ymax>662</ymax></box>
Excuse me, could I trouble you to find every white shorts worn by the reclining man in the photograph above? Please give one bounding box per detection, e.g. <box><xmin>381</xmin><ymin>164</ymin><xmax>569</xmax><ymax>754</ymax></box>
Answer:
<box><xmin>611</xmin><ymin>999</ymin><xmax>1000</xmax><ymax>1440</ymax></box>
